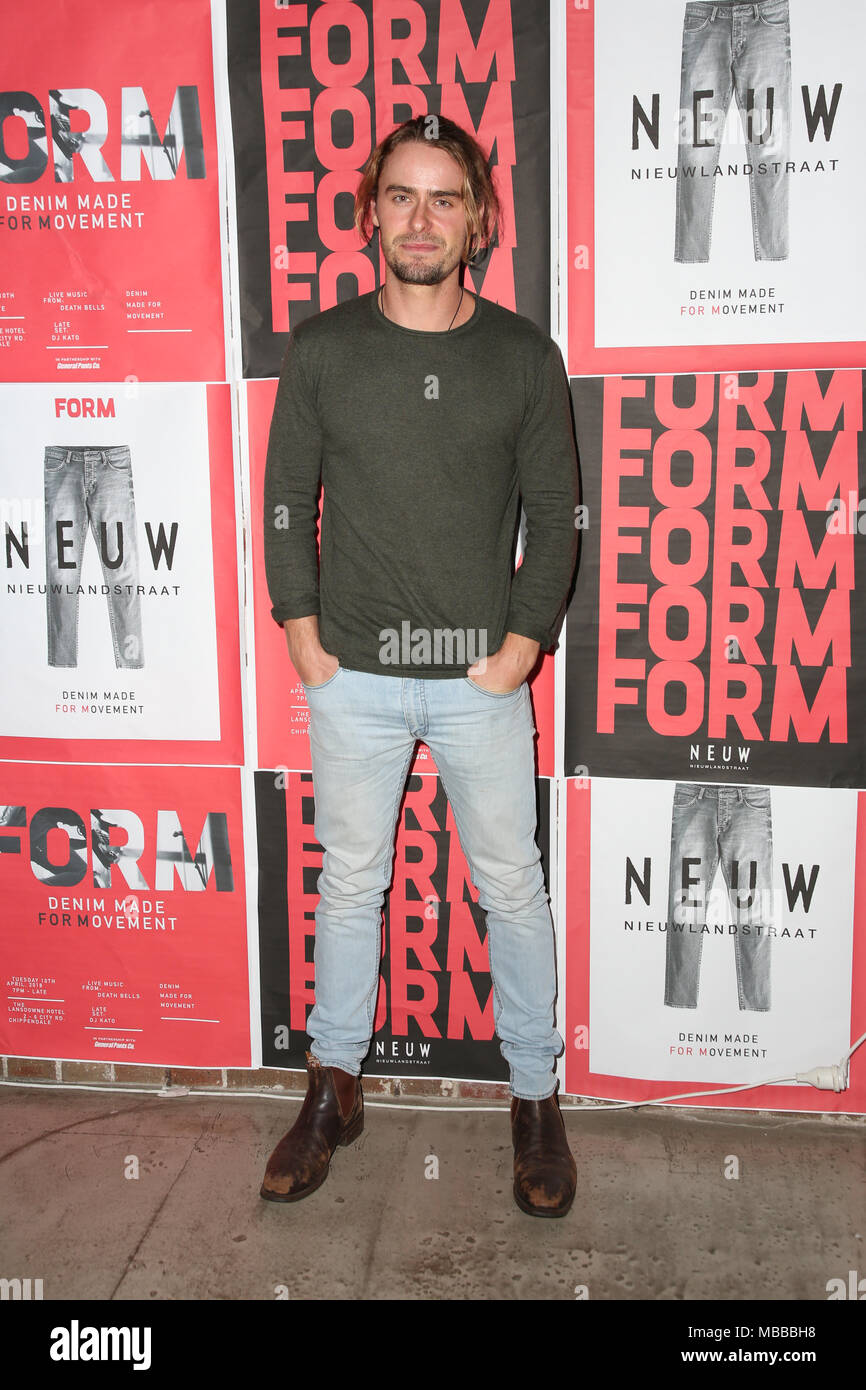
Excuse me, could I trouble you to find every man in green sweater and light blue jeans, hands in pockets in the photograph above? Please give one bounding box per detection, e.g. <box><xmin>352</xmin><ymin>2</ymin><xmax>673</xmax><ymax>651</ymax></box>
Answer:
<box><xmin>261</xmin><ymin>117</ymin><xmax>577</xmax><ymax>1216</ymax></box>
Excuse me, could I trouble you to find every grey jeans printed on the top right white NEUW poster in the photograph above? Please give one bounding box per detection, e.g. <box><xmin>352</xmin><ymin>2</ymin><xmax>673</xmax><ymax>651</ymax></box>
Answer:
<box><xmin>674</xmin><ymin>0</ymin><xmax>791</xmax><ymax>263</ymax></box>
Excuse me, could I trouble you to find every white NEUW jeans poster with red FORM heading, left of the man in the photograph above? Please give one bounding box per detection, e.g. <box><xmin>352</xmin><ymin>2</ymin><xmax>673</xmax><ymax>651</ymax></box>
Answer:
<box><xmin>0</xmin><ymin>382</ymin><xmax>243</xmax><ymax>763</ymax></box>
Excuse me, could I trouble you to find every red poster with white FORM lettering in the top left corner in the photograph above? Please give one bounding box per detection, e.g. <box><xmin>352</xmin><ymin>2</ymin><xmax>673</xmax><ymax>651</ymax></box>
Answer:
<box><xmin>0</xmin><ymin>0</ymin><xmax>225</xmax><ymax>380</ymax></box>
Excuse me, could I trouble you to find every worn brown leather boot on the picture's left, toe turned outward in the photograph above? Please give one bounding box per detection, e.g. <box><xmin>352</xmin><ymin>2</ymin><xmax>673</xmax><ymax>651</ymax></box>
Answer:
<box><xmin>260</xmin><ymin>1052</ymin><xmax>364</xmax><ymax>1202</ymax></box>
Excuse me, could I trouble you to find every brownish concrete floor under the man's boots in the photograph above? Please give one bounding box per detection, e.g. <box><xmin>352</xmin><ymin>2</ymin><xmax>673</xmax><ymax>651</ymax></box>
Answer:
<box><xmin>0</xmin><ymin>1084</ymin><xmax>866</xmax><ymax>1301</ymax></box>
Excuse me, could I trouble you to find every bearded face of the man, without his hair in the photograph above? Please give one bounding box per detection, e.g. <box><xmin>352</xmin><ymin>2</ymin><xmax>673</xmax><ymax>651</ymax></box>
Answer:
<box><xmin>373</xmin><ymin>140</ymin><xmax>468</xmax><ymax>285</ymax></box>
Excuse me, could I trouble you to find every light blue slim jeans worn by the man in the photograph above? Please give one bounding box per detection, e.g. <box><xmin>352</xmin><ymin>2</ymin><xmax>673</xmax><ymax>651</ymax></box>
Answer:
<box><xmin>304</xmin><ymin>667</ymin><xmax>563</xmax><ymax>1099</ymax></box>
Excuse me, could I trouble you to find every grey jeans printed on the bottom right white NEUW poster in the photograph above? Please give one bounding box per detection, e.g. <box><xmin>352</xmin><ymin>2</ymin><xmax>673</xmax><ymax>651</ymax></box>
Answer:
<box><xmin>664</xmin><ymin>783</ymin><xmax>773</xmax><ymax>1012</ymax></box>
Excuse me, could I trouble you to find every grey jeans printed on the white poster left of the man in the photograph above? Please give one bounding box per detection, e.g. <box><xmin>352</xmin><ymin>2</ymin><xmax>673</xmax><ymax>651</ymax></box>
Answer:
<box><xmin>44</xmin><ymin>445</ymin><xmax>145</xmax><ymax>669</ymax></box>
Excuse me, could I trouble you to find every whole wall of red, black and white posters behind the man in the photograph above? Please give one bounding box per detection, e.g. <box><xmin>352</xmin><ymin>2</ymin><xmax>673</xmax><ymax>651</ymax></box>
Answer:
<box><xmin>0</xmin><ymin>0</ymin><xmax>866</xmax><ymax>1111</ymax></box>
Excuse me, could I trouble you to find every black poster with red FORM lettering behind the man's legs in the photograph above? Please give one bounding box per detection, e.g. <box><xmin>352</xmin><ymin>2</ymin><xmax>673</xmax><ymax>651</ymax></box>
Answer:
<box><xmin>256</xmin><ymin>771</ymin><xmax>549</xmax><ymax>1081</ymax></box>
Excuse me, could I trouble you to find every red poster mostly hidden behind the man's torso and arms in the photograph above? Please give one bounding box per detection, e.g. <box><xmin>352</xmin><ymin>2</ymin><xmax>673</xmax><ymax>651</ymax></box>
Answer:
<box><xmin>246</xmin><ymin>381</ymin><xmax>555</xmax><ymax>777</ymax></box>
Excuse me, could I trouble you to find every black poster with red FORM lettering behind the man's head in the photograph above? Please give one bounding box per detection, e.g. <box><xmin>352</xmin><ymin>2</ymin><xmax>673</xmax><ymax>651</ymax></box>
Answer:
<box><xmin>228</xmin><ymin>0</ymin><xmax>550</xmax><ymax>377</ymax></box>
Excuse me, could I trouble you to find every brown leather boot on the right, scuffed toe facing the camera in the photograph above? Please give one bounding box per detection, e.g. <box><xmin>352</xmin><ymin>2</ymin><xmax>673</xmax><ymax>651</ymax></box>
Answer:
<box><xmin>512</xmin><ymin>1091</ymin><xmax>577</xmax><ymax>1216</ymax></box>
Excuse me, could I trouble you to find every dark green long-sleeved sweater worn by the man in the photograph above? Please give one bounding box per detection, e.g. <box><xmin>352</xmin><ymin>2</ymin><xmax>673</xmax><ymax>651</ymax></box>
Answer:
<box><xmin>264</xmin><ymin>293</ymin><xmax>578</xmax><ymax>678</ymax></box>
